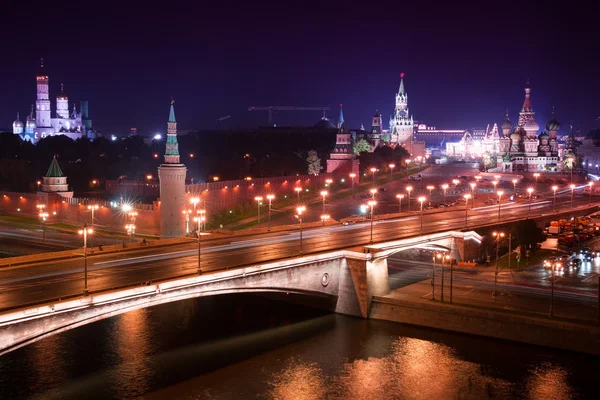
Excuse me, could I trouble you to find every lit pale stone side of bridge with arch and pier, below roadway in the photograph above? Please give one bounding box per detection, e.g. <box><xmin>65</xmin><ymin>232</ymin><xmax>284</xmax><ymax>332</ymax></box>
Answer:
<box><xmin>0</xmin><ymin>231</ymin><xmax>481</xmax><ymax>355</ymax></box>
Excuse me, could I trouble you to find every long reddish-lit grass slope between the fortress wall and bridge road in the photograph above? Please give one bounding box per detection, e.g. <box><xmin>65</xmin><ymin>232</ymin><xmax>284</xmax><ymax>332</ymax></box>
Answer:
<box><xmin>208</xmin><ymin>165</ymin><xmax>429</xmax><ymax>230</ymax></box>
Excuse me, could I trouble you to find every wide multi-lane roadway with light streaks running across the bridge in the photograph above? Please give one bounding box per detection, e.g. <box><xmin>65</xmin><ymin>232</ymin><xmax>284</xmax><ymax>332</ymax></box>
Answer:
<box><xmin>0</xmin><ymin>195</ymin><xmax>587</xmax><ymax>310</ymax></box>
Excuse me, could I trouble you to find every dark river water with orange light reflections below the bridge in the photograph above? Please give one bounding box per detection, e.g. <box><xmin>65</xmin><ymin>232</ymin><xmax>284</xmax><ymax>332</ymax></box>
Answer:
<box><xmin>0</xmin><ymin>295</ymin><xmax>600</xmax><ymax>400</ymax></box>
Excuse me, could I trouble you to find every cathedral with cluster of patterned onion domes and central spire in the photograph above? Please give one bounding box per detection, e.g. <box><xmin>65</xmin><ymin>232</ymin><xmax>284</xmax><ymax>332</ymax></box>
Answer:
<box><xmin>497</xmin><ymin>87</ymin><xmax>574</xmax><ymax>172</ymax></box>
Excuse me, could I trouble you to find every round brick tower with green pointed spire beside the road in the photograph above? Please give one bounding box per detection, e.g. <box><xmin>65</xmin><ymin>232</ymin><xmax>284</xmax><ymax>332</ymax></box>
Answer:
<box><xmin>158</xmin><ymin>99</ymin><xmax>187</xmax><ymax>237</ymax></box>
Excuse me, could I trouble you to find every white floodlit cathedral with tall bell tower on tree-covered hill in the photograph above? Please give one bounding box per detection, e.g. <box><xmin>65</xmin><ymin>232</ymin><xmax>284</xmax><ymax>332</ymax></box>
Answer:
<box><xmin>13</xmin><ymin>59</ymin><xmax>93</xmax><ymax>143</ymax></box>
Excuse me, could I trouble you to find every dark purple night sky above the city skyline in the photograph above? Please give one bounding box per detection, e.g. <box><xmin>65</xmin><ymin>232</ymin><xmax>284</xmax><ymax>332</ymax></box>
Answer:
<box><xmin>0</xmin><ymin>1</ymin><xmax>600</xmax><ymax>135</ymax></box>
